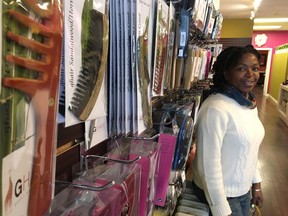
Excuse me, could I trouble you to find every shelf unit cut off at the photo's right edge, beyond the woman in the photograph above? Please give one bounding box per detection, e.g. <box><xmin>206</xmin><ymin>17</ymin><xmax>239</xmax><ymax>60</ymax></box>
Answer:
<box><xmin>278</xmin><ymin>85</ymin><xmax>288</xmax><ymax>126</ymax></box>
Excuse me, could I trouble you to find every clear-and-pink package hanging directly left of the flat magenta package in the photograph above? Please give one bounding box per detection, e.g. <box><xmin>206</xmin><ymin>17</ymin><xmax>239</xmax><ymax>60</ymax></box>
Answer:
<box><xmin>104</xmin><ymin>136</ymin><xmax>160</xmax><ymax>216</ymax></box>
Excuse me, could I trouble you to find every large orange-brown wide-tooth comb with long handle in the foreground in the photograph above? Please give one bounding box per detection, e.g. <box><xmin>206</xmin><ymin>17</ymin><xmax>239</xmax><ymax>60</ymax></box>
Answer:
<box><xmin>3</xmin><ymin>0</ymin><xmax>63</xmax><ymax>216</ymax></box>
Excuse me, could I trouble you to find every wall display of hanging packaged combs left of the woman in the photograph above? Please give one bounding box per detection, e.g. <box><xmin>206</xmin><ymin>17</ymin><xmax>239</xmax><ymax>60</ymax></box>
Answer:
<box><xmin>0</xmin><ymin>0</ymin><xmax>223</xmax><ymax>216</ymax></box>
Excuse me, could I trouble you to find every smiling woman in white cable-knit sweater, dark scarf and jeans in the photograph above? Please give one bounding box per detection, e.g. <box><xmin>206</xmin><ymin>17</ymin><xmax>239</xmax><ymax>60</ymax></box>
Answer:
<box><xmin>193</xmin><ymin>45</ymin><xmax>265</xmax><ymax>216</ymax></box>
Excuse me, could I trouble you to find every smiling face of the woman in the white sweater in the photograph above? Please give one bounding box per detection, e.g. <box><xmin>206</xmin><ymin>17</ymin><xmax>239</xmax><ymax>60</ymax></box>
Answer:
<box><xmin>224</xmin><ymin>53</ymin><xmax>259</xmax><ymax>96</ymax></box>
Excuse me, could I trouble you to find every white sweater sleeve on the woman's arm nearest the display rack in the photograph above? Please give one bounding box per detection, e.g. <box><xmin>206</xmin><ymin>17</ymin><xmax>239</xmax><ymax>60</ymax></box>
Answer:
<box><xmin>196</xmin><ymin>107</ymin><xmax>231</xmax><ymax>216</ymax></box>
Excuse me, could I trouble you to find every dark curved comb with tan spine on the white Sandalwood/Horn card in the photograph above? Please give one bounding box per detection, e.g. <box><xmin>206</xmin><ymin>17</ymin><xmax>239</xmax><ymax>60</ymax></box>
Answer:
<box><xmin>69</xmin><ymin>0</ymin><xmax>109</xmax><ymax>121</ymax></box>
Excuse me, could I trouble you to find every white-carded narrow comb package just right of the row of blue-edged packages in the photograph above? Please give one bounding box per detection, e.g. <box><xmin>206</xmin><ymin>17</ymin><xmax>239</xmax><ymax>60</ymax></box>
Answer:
<box><xmin>136</xmin><ymin>0</ymin><xmax>154</xmax><ymax>134</ymax></box>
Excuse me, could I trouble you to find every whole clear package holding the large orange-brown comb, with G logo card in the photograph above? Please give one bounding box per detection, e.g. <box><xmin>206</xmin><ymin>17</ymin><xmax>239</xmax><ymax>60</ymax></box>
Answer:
<box><xmin>0</xmin><ymin>0</ymin><xmax>63</xmax><ymax>216</ymax></box>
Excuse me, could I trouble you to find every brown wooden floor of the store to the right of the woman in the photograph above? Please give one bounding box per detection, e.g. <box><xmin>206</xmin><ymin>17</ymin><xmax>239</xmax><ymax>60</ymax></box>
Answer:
<box><xmin>254</xmin><ymin>86</ymin><xmax>288</xmax><ymax>216</ymax></box>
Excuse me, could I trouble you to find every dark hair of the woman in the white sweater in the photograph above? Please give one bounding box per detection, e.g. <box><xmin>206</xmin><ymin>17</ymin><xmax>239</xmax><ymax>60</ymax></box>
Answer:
<box><xmin>212</xmin><ymin>45</ymin><xmax>261</xmax><ymax>90</ymax></box>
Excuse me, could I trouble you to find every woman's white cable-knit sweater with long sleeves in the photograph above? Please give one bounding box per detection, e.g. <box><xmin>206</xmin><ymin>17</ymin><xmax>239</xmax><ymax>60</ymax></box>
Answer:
<box><xmin>193</xmin><ymin>93</ymin><xmax>264</xmax><ymax>216</ymax></box>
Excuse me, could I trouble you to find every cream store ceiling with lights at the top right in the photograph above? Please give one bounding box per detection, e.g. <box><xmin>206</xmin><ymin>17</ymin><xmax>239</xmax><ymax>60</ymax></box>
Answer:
<box><xmin>220</xmin><ymin>0</ymin><xmax>288</xmax><ymax>31</ymax></box>
